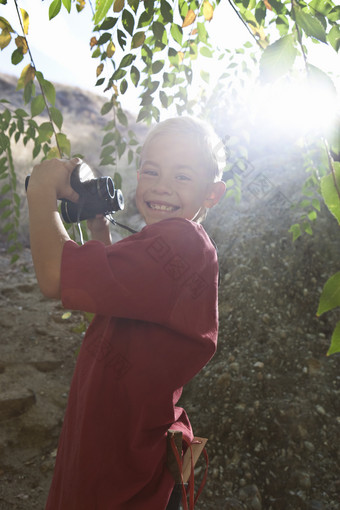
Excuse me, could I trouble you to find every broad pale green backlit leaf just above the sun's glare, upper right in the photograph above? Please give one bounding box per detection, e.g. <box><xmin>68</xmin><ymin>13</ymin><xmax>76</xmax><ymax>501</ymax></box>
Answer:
<box><xmin>260</xmin><ymin>34</ymin><xmax>297</xmax><ymax>82</ymax></box>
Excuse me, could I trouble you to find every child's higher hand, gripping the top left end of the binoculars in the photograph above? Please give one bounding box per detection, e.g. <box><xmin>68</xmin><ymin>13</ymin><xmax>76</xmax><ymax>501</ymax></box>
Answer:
<box><xmin>27</xmin><ymin>158</ymin><xmax>81</xmax><ymax>202</ymax></box>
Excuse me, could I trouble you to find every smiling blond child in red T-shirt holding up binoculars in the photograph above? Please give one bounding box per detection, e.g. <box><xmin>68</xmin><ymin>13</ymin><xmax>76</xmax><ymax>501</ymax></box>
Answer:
<box><xmin>27</xmin><ymin>118</ymin><xmax>225</xmax><ymax>510</ymax></box>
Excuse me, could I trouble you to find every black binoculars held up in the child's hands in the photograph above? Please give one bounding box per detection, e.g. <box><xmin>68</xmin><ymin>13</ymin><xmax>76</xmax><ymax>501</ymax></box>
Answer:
<box><xmin>25</xmin><ymin>163</ymin><xmax>124</xmax><ymax>223</ymax></box>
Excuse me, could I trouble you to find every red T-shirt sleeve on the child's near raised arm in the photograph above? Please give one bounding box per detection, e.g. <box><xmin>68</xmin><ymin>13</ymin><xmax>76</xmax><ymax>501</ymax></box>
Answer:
<box><xmin>61</xmin><ymin>219</ymin><xmax>218</xmax><ymax>336</ymax></box>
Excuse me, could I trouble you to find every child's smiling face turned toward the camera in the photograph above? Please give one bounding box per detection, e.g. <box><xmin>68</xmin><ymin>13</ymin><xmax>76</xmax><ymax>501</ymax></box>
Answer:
<box><xmin>136</xmin><ymin>134</ymin><xmax>212</xmax><ymax>225</ymax></box>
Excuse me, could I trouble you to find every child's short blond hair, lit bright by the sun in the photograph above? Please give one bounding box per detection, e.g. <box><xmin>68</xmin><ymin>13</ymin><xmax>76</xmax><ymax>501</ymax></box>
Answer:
<box><xmin>141</xmin><ymin>117</ymin><xmax>226</xmax><ymax>182</ymax></box>
